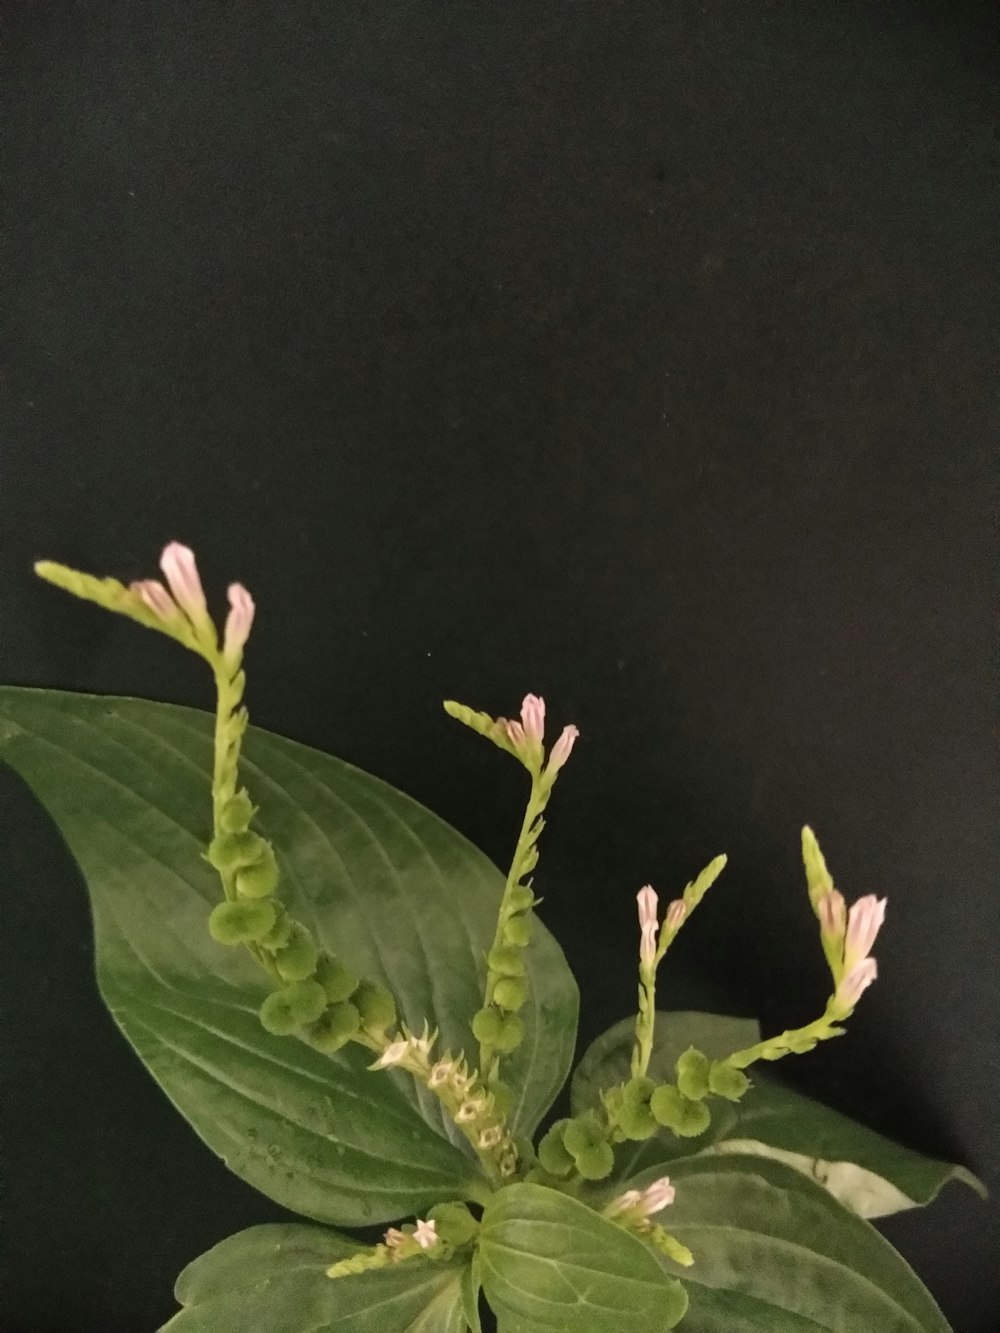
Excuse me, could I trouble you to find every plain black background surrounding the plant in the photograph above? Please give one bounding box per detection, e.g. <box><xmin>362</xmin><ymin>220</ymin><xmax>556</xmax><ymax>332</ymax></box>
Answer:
<box><xmin>0</xmin><ymin>0</ymin><xmax>1000</xmax><ymax>1333</ymax></box>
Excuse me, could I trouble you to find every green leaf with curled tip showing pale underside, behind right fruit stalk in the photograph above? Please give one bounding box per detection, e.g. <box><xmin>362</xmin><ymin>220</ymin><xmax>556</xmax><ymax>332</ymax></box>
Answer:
<box><xmin>572</xmin><ymin>1013</ymin><xmax>985</xmax><ymax>1217</ymax></box>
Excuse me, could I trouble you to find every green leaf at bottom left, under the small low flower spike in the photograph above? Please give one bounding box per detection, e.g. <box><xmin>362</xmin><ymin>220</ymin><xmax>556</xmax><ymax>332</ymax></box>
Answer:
<box><xmin>161</xmin><ymin>1224</ymin><xmax>465</xmax><ymax>1333</ymax></box>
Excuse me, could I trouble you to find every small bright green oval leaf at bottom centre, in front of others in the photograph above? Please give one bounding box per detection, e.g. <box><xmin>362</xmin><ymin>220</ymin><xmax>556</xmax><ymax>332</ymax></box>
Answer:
<box><xmin>480</xmin><ymin>1185</ymin><xmax>688</xmax><ymax>1333</ymax></box>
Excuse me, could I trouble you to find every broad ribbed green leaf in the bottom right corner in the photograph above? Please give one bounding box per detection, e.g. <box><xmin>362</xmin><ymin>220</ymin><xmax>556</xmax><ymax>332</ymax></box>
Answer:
<box><xmin>629</xmin><ymin>1154</ymin><xmax>948</xmax><ymax>1333</ymax></box>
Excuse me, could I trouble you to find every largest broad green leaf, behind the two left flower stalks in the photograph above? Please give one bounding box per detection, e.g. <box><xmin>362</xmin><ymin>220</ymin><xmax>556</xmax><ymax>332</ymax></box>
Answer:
<box><xmin>0</xmin><ymin>688</ymin><xmax>577</xmax><ymax>1225</ymax></box>
